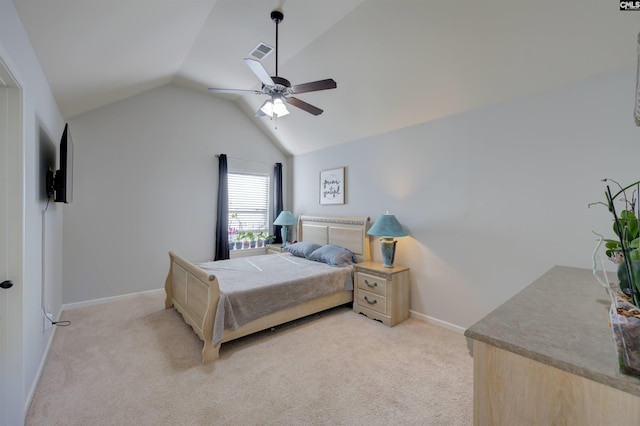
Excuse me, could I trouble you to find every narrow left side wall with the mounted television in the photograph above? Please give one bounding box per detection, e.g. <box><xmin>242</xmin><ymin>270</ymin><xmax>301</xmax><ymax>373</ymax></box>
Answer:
<box><xmin>0</xmin><ymin>0</ymin><xmax>64</xmax><ymax>420</ymax></box>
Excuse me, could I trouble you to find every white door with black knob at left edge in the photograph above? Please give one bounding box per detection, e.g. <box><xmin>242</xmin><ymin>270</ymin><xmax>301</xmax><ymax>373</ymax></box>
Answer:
<box><xmin>0</xmin><ymin>58</ymin><xmax>24</xmax><ymax>426</ymax></box>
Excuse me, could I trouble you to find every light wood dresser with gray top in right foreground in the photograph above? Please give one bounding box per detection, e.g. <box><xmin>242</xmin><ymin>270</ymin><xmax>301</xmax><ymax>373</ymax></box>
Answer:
<box><xmin>465</xmin><ymin>266</ymin><xmax>640</xmax><ymax>426</ymax></box>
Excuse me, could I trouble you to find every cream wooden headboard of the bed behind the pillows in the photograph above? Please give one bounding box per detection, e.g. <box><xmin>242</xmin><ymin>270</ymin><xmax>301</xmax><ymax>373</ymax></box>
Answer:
<box><xmin>298</xmin><ymin>214</ymin><xmax>371</xmax><ymax>262</ymax></box>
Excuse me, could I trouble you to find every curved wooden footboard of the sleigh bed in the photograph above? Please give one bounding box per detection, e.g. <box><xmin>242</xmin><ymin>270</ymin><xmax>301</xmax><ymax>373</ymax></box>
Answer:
<box><xmin>164</xmin><ymin>251</ymin><xmax>220</xmax><ymax>363</ymax></box>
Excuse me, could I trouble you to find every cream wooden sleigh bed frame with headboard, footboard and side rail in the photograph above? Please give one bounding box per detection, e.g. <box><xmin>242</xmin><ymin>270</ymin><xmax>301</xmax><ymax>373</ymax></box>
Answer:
<box><xmin>165</xmin><ymin>215</ymin><xmax>371</xmax><ymax>363</ymax></box>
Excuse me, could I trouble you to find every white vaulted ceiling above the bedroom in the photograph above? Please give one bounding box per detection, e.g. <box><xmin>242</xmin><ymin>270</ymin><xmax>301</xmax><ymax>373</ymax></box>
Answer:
<box><xmin>13</xmin><ymin>0</ymin><xmax>640</xmax><ymax>155</ymax></box>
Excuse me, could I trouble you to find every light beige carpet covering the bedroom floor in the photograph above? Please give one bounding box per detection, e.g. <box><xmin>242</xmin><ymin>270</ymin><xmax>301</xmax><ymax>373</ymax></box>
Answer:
<box><xmin>26</xmin><ymin>294</ymin><xmax>473</xmax><ymax>426</ymax></box>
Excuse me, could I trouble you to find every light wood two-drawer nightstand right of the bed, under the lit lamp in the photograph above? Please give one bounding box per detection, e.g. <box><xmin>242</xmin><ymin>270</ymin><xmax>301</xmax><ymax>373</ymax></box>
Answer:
<box><xmin>353</xmin><ymin>262</ymin><xmax>410</xmax><ymax>327</ymax></box>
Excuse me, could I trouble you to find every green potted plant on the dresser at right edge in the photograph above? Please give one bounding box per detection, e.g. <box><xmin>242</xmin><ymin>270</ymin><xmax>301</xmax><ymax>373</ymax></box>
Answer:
<box><xmin>590</xmin><ymin>179</ymin><xmax>640</xmax><ymax>376</ymax></box>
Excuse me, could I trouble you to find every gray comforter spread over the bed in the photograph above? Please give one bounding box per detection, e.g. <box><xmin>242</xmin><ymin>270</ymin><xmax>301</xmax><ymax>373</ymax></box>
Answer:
<box><xmin>197</xmin><ymin>253</ymin><xmax>353</xmax><ymax>346</ymax></box>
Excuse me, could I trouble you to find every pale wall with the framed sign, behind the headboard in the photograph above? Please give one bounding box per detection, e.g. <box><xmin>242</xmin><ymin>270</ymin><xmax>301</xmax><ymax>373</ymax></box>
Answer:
<box><xmin>293</xmin><ymin>70</ymin><xmax>640</xmax><ymax>328</ymax></box>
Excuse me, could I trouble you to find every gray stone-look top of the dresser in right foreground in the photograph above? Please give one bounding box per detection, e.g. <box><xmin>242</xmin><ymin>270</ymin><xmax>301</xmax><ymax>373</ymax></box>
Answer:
<box><xmin>465</xmin><ymin>266</ymin><xmax>640</xmax><ymax>396</ymax></box>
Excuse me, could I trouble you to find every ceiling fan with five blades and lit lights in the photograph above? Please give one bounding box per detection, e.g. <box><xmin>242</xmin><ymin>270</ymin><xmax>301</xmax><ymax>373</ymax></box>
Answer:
<box><xmin>209</xmin><ymin>10</ymin><xmax>337</xmax><ymax>117</ymax></box>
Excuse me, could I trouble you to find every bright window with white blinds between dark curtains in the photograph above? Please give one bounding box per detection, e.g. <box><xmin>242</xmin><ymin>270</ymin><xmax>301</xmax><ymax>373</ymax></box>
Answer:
<box><xmin>228</xmin><ymin>172</ymin><xmax>270</xmax><ymax>239</ymax></box>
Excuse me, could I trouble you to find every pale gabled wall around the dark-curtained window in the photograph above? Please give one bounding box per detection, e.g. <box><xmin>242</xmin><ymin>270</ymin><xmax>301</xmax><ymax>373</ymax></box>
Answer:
<box><xmin>63</xmin><ymin>85</ymin><xmax>288</xmax><ymax>303</ymax></box>
